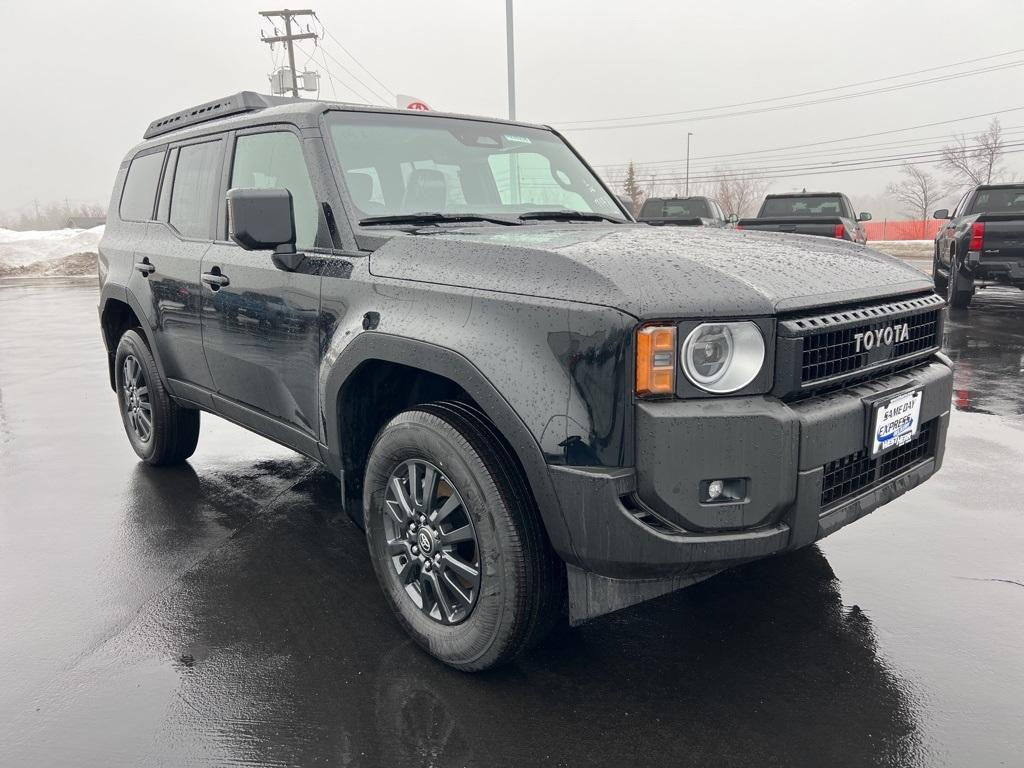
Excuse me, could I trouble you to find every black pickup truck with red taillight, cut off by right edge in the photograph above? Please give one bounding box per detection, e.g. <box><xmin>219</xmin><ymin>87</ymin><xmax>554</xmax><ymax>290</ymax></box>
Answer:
<box><xmin>932</xmin><ymin>183</ymin><xmax>1024</xmax><ymax>309</ymax></box>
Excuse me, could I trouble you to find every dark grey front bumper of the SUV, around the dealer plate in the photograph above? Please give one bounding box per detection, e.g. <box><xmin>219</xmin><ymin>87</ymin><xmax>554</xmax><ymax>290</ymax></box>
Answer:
<box><xmin>550</xmin><ymin>355</ymin><xmax>952</xmax><ymax>580</ymax></box>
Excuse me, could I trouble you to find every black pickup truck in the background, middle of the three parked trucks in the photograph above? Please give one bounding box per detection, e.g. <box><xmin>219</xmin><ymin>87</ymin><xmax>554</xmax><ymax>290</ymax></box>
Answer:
<box><xmin>736</xmin><ymin>193</ymin><xmax>871</xmax><ymax>245</ymax></box>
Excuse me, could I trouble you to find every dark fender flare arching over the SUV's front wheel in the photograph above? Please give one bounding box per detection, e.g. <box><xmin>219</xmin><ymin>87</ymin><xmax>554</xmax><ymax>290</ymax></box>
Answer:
<box><xmin>324</xmin><ymin>332</ymin><xmax>578</xmax><ymax>562</ymax></box>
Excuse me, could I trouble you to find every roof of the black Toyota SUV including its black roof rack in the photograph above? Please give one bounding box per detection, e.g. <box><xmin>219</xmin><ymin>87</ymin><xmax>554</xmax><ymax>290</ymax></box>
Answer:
<box><xmin>129</xmin><ymin>91</ymin><xmax>551</xmax><ymax>156</ymax></box>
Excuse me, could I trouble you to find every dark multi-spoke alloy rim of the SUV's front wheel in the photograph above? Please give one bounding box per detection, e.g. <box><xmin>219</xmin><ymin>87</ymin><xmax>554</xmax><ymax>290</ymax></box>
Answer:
<box><xmin>382</xmin><ymin>459</ymin><xmax>481</xmax><ymax>625</ymax></box>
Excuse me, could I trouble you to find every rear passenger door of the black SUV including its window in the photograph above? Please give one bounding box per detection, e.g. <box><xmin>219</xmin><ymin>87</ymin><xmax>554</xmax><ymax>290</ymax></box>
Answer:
<box><xmin>133</xmin><ymin>137</ymin><xmax>224</xmax><ymax>397</ymax></box>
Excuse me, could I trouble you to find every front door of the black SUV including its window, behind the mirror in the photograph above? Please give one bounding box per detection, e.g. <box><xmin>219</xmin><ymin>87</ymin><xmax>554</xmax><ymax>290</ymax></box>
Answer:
<box><xmin>202</xmin><ymin>127</ymin><xmax>321</xmax><ymax>453</ymax></box>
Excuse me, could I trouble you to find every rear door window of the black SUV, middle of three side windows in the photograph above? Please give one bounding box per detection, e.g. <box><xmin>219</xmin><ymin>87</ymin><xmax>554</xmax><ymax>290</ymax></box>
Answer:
<box><xmin>168</xmin><ymin>140</ymin><xmax>220</xmax><ymax>240</ymax></box>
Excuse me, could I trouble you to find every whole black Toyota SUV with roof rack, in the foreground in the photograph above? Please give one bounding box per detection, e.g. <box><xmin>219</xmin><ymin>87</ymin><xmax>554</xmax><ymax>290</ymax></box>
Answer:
<box><xmin>99</xmin><ymin>92</ymin><xmax>952</xmax><ymax>670</ymax></box>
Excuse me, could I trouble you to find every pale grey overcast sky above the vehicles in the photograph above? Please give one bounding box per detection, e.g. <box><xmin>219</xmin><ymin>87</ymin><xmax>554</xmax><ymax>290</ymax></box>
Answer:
<box><xmin>0</xmin><ymin>0</ymin><xmax>1024</xmax><ymax>211</ymax></box>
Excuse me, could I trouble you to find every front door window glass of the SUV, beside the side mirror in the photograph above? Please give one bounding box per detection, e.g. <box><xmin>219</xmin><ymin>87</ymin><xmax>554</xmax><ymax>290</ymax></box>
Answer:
<box><xmin>231</xmin><ymin>131</ymin><xmax>319</xmax><ymax>248</ymax></box>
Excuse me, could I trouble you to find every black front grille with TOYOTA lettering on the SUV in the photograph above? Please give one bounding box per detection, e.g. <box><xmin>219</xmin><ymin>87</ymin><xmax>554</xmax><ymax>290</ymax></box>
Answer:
<box><xmin>778</xmin><ymin>294</ymin><xmax>944</xmax><ymax>394</ymax></box>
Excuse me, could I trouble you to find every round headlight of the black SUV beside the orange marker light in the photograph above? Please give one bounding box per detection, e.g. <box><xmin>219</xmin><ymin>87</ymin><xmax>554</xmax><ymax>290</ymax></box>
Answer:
<box><xmin>682</xmin><ymin>322</ymin><xmax>765</xmax><ymax>394</ymax></box>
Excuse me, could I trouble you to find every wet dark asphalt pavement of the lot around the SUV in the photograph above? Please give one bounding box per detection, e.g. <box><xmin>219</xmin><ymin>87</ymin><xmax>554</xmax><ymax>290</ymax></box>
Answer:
<box><xmin>0</xmin><ymin>284</ymin><xmax>1024</xmax><ymax>767</ymax></box>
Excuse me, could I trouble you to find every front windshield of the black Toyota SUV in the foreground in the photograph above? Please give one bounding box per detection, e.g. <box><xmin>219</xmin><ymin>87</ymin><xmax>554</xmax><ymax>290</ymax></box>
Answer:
<box><xmin>326</xmin><ymin>112</ymin><xmax>625</xmax><ymax>223</ymax></box>
